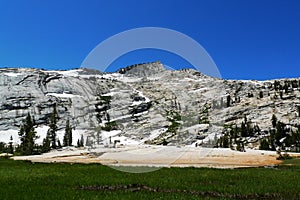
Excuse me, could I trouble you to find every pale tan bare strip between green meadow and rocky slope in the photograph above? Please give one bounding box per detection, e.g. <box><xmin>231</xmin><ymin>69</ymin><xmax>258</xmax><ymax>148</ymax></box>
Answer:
<box><xmin>13</xmin><ymin>145</ymin><xmax>286</xmax><ymax>168</ymax></box>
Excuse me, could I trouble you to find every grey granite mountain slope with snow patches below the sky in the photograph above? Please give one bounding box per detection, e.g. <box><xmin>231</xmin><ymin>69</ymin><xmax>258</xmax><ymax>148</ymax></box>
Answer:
<box><xmin>0</xmin><ymin>62</ymin><xmax>300</xmax><ymax>147</ymax></box>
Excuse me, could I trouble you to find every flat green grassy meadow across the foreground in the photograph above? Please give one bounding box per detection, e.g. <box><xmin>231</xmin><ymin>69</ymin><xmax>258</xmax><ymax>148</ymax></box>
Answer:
<box><xmin>0</xmin><ymin>158</ymin><xmax>300</xmax><ymax>200</ymax></box>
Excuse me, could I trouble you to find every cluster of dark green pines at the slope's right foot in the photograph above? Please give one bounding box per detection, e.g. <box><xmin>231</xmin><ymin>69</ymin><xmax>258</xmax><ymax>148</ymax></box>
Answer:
<box><xmin>216</xmin><ymin>114</ymin><xmax>300</xmax><ymax>152</ymax></box>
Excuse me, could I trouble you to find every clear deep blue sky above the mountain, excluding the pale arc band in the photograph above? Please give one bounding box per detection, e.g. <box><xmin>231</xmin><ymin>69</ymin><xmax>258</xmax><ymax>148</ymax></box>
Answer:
<box><xmin>0</xmin><ymin>0</ymin><xmax>300</xmax><ymax>80</ymax></box>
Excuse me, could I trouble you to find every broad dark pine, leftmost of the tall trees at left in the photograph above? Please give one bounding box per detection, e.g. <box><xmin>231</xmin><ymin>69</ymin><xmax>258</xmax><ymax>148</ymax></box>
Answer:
<box><xmin>19</xmin><ymin>113</ymin><xmax>37</xmax><ymax>155</ymax></box>
